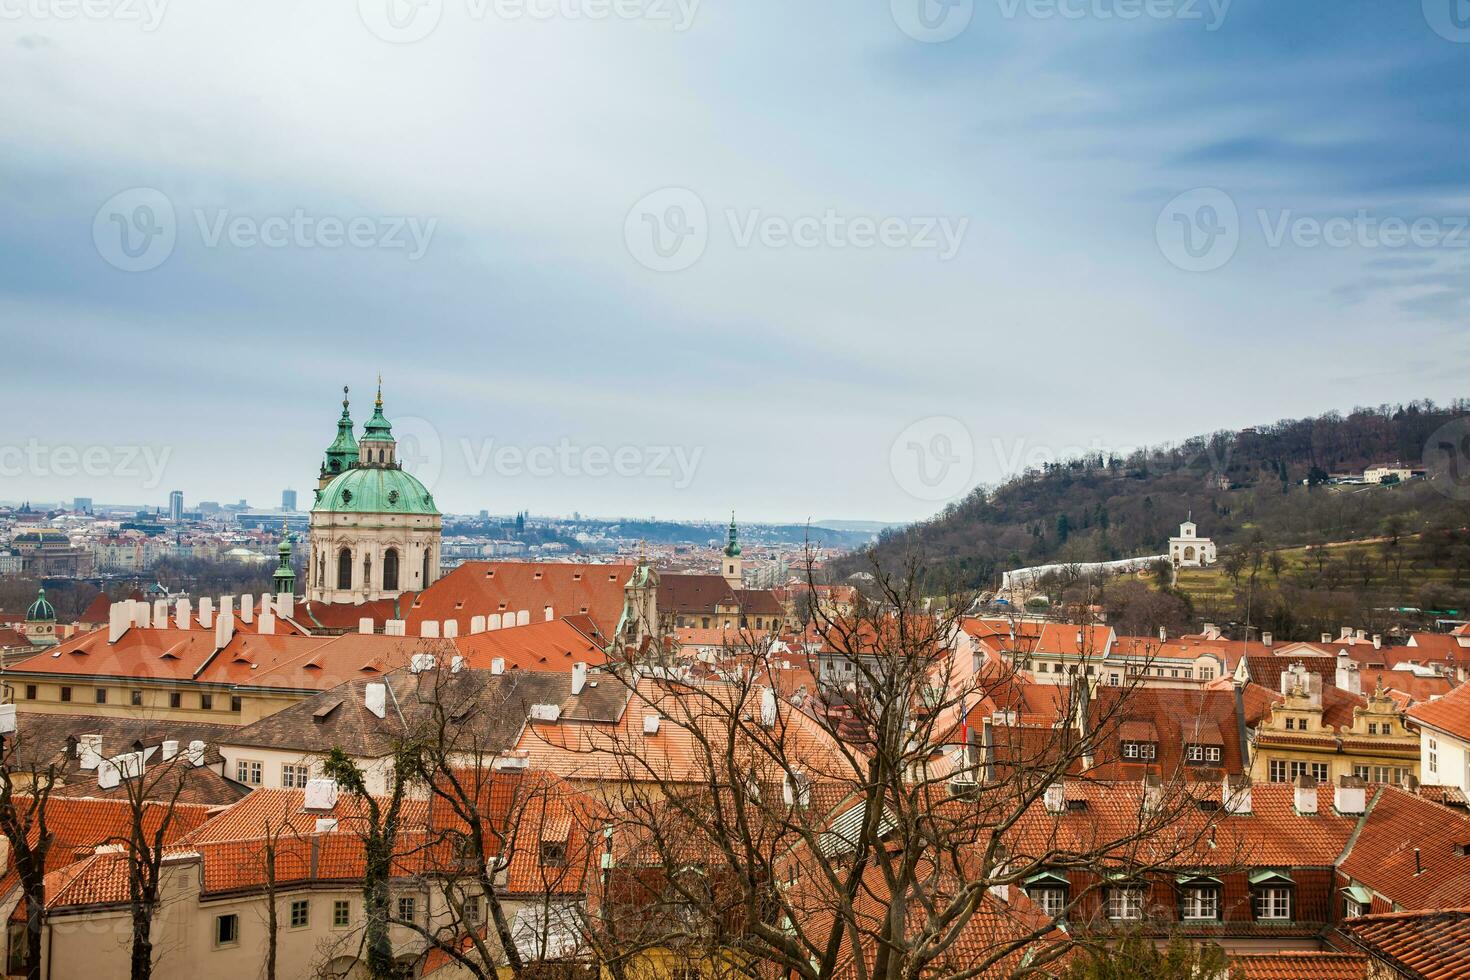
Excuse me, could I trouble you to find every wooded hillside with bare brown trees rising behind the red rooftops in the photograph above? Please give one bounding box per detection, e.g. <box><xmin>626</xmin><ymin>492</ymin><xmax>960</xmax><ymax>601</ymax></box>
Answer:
<box><xmin>836</xmin><ymin>401</ymin><xmax>1470</xmax><ymax>598</ymax></box>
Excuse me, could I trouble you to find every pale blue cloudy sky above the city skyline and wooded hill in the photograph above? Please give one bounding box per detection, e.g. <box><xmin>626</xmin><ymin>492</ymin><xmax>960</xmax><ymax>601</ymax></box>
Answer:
<box><xmin>0</xmin><ymin>0</ymin><xmax>1470</xmax><ymax>522</ymax></box>
